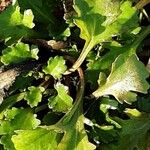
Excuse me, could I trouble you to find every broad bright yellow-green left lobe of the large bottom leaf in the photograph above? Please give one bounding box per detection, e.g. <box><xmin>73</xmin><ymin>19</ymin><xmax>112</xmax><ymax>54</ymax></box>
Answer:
<box><xmin>12</xmin><ymin>128</ymin><xmax>62</xmax><ymax>150</ymax></box>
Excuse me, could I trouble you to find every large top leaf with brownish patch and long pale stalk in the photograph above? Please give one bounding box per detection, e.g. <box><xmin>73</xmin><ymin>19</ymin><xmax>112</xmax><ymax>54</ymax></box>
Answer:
<box><xmin>70</xmin><ymin>0</ymin><xmax>138</xmax><ymax>71</ymax></box>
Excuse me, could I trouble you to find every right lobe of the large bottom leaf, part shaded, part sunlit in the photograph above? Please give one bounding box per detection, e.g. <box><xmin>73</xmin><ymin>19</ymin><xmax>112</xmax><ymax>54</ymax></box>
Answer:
<box><xmin>58</xmin><ymin>114</ymin><xmax>96</xmax><ymax>150</ymax></box>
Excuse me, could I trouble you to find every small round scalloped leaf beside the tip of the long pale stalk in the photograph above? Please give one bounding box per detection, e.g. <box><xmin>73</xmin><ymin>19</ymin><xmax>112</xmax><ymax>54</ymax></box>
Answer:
<box><xmin>43</xmin><ymin>56</ymin><xmax>67</xmax><ymax>79</ymax></box>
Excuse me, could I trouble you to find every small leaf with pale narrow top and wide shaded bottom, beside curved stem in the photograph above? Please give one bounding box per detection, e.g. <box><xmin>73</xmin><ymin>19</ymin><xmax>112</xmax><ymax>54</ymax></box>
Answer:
<box><xmin>48</xmin><ymin>83</ymin><xmax>73</xmax><ymax>112</ymax></box>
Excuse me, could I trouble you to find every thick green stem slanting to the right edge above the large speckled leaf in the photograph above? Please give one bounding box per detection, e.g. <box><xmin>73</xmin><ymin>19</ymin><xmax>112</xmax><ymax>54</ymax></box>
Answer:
<box><xmin>130</xmin><ymin>25</ymin><xmax>150</xmax><ymax>53</ymax></box>
